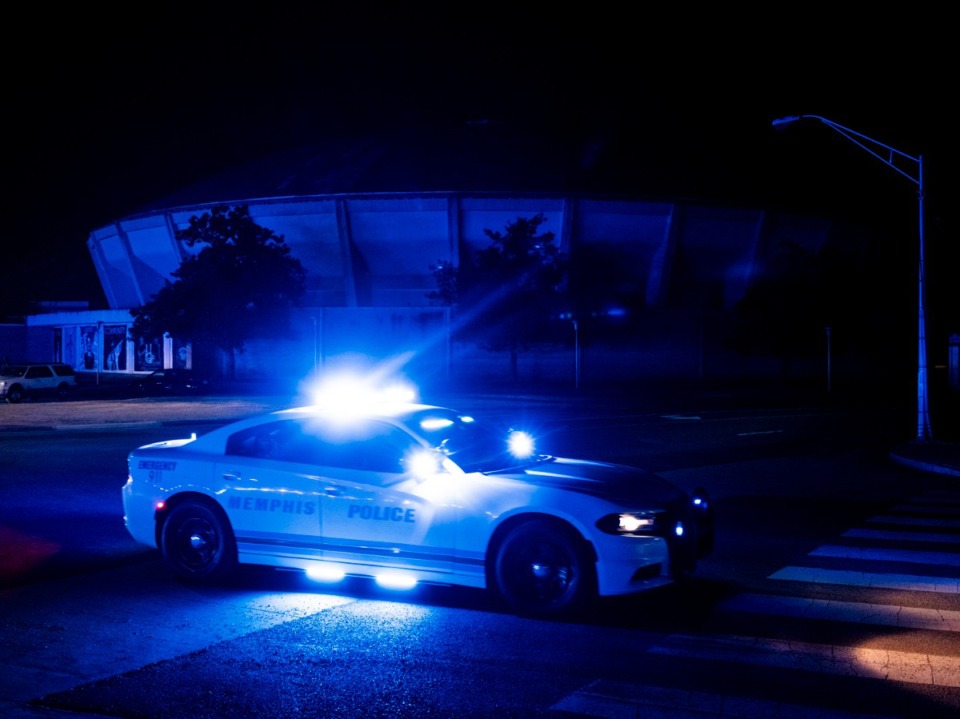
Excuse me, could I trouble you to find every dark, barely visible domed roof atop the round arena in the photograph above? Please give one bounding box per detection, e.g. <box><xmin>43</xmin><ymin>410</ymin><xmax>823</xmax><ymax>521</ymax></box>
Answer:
<box><xmin>133</xmin><ymin>120</ymin><xmax>756</xmax><ymax>217</ymax></box>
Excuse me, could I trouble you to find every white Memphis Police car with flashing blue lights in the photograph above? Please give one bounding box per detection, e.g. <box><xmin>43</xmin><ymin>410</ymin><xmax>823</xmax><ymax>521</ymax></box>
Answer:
<box><xmin>122</xmin><ymin>386</ymin><xmax>713</xmax><ymax>617</ymax></box>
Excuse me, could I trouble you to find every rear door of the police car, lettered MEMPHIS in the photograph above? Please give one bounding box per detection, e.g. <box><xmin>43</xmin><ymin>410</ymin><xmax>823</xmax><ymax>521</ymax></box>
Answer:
<box><xmin>214</xmin><ymin>420</ymin><xmax>323</xmax><ymax>561</ymax></box>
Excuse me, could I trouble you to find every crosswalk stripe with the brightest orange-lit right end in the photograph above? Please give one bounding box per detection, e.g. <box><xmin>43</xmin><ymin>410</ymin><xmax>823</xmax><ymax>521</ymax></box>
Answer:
<box><xmin>647</xmin><ymin>634</ymin><xmax>960</xmax><ymax>687</ymax></box>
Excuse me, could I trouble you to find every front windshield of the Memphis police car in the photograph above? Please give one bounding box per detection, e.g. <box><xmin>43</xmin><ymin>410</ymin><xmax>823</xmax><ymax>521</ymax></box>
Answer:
<box><xmin>413</xmin><ymin>410</ymin><xmax>549</xmax><ymax>472</ymax></box>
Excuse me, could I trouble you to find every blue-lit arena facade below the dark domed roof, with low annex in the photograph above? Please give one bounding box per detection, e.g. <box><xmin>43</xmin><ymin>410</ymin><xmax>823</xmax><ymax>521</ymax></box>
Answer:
<box><xmin>11</xmin><ymin>193</ymin><xmax>852</xmax><ymax>388</ymax></box>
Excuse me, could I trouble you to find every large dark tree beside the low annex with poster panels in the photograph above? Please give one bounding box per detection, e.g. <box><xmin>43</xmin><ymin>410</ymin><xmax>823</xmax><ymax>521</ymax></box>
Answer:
<box><xmin>130</xmin><ymin>205</ymin><xmax>306</xmax><ymax>377</ymax></box>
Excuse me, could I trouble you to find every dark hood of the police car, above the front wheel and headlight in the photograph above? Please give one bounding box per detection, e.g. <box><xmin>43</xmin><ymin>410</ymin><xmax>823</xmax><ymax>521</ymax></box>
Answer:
<box><xmin>496</xmin><ymin>457</ymin><xmax>685</xmax><ymax>506</ymax></box>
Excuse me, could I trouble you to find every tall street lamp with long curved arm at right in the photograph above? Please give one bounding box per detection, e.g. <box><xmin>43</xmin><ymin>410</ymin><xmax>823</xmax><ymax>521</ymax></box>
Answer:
<box><xmin>772</xmin><ymin>115</ymin><xmax>933</xmax><ymax>442</ymax></box>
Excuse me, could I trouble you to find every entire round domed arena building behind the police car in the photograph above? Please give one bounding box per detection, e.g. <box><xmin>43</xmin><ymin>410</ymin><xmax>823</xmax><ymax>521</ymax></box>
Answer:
<box><xmin>16</xmin><ymin>122</ymin><xmax>884</xmax><ymax>394</ymax></box>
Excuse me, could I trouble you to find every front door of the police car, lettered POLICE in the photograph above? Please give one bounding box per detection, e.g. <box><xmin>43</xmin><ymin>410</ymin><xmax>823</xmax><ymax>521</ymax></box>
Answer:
<box><xmin>314</xmin><ymin>420</ymin><xmax>459</xmax><ymax>574</ymax></box>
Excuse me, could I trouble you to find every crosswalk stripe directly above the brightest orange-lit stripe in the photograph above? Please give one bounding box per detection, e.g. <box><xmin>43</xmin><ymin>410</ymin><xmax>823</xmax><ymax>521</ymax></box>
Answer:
<box><xmin>717</xmin><ymin>592</ymin><xmax>960</xmax><ymax>633</ymax></box>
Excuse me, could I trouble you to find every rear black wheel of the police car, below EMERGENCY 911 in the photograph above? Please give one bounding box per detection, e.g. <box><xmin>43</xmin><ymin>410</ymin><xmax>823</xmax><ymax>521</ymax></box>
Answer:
<box><xmin>160</xmin><ymin>501</ymin><xmax>237</xmax><ymax>582</ymax></box>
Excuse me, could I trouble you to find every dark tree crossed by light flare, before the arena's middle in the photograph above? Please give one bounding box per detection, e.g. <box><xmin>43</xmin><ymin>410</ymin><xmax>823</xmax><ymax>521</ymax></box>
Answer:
<box><xmin>428</xmin><ymin>213</ymin><xmax>566</xmax><ymax>379</ymax></box>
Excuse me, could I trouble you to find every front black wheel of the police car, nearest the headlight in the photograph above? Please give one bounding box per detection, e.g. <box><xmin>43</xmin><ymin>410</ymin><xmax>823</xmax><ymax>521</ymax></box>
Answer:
<box><xmin>493</xmin><ymin>519</ymin><xmax>597</xmax><ymax>618</ymax></box>
